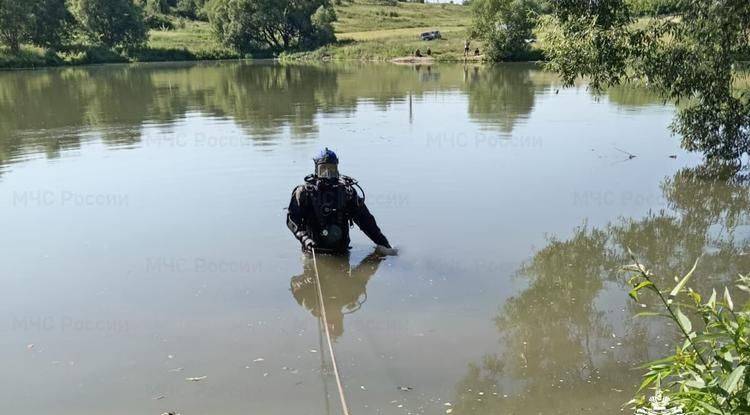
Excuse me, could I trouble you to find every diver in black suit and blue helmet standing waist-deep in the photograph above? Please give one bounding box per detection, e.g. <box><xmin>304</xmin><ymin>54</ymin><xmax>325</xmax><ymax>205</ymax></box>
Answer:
<box><xmin>286</xmin><ymin>148</ymin><xmax>397</xmax><ymax>255</ymax></box>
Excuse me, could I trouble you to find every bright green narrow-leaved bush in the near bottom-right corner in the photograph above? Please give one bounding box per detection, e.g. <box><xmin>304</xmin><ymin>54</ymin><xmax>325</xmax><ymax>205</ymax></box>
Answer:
<box><xmin>627</xmin><ymin>260</ymin><xmax>750</xmax><ymax>415</ymax></box>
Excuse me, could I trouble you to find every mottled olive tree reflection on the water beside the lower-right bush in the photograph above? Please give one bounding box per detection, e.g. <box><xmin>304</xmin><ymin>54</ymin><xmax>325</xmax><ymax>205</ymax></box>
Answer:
<box><xmin>454</xmin><ymin>167</ymin><xmax>750</xmax><ymax>414</ymax></box>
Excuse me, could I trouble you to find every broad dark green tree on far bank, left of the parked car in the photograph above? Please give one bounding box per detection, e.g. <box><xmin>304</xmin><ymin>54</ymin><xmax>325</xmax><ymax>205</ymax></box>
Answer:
<box><xmin>208</xmin><ymin>0</ymin><xmax>336</xmax><ymax>52</ymax></box>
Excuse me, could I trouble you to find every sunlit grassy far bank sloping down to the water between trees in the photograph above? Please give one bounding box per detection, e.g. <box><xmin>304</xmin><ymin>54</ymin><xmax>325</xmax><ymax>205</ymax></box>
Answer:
<box><xmin>0</xmin><ymin>0</ymin><xmax>482</xmax><ymax>68</ymax></box>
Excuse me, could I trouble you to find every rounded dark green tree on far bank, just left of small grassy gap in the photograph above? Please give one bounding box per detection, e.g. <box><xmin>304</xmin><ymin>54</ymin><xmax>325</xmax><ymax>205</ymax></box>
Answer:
<box><xmin>73</xmin><ymin>0</ymin><xmax>148</xmax><ymax>48</ymax></box>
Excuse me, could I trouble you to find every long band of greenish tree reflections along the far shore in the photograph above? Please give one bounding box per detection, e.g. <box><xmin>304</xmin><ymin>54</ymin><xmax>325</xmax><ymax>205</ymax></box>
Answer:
<box><xmin>0</xmin><ymin>63</ymin><xmax>668</xmax><ymax>175</ymax></box>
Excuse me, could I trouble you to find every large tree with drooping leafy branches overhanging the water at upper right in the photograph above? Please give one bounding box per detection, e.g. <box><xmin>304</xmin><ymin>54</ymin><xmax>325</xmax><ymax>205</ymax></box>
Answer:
<box><xmin>544</xmin><ymin>0</ymin><xmax>750</xmax><ymax>162</ymax></box>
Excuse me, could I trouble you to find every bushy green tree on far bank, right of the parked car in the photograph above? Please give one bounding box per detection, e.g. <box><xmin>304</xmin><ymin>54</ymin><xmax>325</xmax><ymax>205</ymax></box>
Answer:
<box><xmin>472</xmin><ymin>0</ymin><xmax>539</xmax><ymax>61</ymax></box>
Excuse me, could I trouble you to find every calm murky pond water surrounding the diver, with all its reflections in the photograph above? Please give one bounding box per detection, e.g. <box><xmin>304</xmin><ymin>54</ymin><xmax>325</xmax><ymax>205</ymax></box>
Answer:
<box><xmin>0</xmin><ymin>62</ymin><xmax>750</xmax><ymax>415</ymax></box>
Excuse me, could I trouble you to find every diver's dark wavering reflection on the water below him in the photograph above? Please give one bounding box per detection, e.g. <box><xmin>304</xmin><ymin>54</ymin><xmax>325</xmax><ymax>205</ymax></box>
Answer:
<box><xmin>291</xmin><ymin>252</ymin><xmax>384</xmax><ymax>340</ymax></box>
